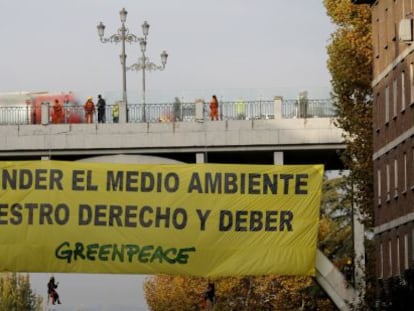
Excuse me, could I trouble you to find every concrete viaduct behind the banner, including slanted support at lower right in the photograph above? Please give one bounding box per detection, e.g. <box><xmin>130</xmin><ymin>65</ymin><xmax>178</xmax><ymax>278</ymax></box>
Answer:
<box><xmin>0</xmin><ymin>108</ymin><xmax>358</xmax><ymax>310</ymax></box>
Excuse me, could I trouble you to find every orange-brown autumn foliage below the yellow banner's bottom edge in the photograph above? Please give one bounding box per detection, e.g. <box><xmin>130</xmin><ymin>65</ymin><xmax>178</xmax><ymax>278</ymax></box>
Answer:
<box><xmin>144</xmin><ymin>275</ymin><xmax>335</xmax><ymax>311</ymax></box>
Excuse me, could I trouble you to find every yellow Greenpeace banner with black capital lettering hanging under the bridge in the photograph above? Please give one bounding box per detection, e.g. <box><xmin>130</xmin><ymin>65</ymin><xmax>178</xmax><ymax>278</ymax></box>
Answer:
<box><xmin>0</xmin><ymin>161</ymin><xmax>323</xmax><ymax>277</ymax></box>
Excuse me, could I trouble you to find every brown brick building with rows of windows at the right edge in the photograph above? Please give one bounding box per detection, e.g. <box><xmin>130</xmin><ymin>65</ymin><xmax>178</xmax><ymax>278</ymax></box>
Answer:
<box><xmin>352</xmin><ymin>0</ymin><xmax>414</xmax><ymax>310</ymax></box>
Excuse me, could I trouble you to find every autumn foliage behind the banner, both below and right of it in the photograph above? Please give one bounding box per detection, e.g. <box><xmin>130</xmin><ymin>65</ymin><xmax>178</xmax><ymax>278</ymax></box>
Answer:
<box><xmin>144</xmin><ymin>177</ymin><xmax>353</xmax><ymax>311</ymax></box>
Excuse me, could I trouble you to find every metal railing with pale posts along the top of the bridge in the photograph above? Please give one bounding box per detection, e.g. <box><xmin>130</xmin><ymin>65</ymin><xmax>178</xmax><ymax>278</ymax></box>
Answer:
<box><xmin>0</xmin><ymin>99</ymin><xmax>336</xmax><ymax>125</ymax></box>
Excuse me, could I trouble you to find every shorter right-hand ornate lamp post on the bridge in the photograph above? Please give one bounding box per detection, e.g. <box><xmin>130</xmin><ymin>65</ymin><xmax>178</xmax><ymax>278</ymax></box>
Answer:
<box><xmin>127</xmin><ymin>21</ymin><xmax>168</xmax><ymax>122</ymax></box>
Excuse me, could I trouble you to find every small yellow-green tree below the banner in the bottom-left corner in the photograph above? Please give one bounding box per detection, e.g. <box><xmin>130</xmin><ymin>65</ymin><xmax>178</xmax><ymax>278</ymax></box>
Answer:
<box><xmin>0</xmin><ymin>273</ymin><xmax>42</xmax><ymax>311</ymax></box>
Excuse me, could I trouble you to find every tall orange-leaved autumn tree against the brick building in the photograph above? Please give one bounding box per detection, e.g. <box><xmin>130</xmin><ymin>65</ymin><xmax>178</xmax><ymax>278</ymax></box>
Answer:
<box><xmin>324</xmin><ymin>0</ymin><xmax>375</xmax><ymax>309</ymax></box>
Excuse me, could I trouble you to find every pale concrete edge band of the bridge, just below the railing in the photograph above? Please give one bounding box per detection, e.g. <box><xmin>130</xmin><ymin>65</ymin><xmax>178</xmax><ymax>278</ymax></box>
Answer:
<box><xmin>0</xmin><ymin>118</ymin><xmax>343</xmax><ymax>152</ymax></box>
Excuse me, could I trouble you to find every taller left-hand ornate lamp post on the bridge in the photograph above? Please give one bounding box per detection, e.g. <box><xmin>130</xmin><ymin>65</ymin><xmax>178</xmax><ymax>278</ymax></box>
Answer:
<box><xmin>97</xmin><ymin>8</ymin><xmax>140</xmax><ymax>105</ymax></box>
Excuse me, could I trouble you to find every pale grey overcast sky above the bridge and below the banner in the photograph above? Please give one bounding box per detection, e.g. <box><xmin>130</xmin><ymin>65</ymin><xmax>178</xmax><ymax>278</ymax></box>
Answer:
<box><xmin>0</xmin><ymin>0</ymin><xmax>333</xmax><ymax>310</ymax></box>
